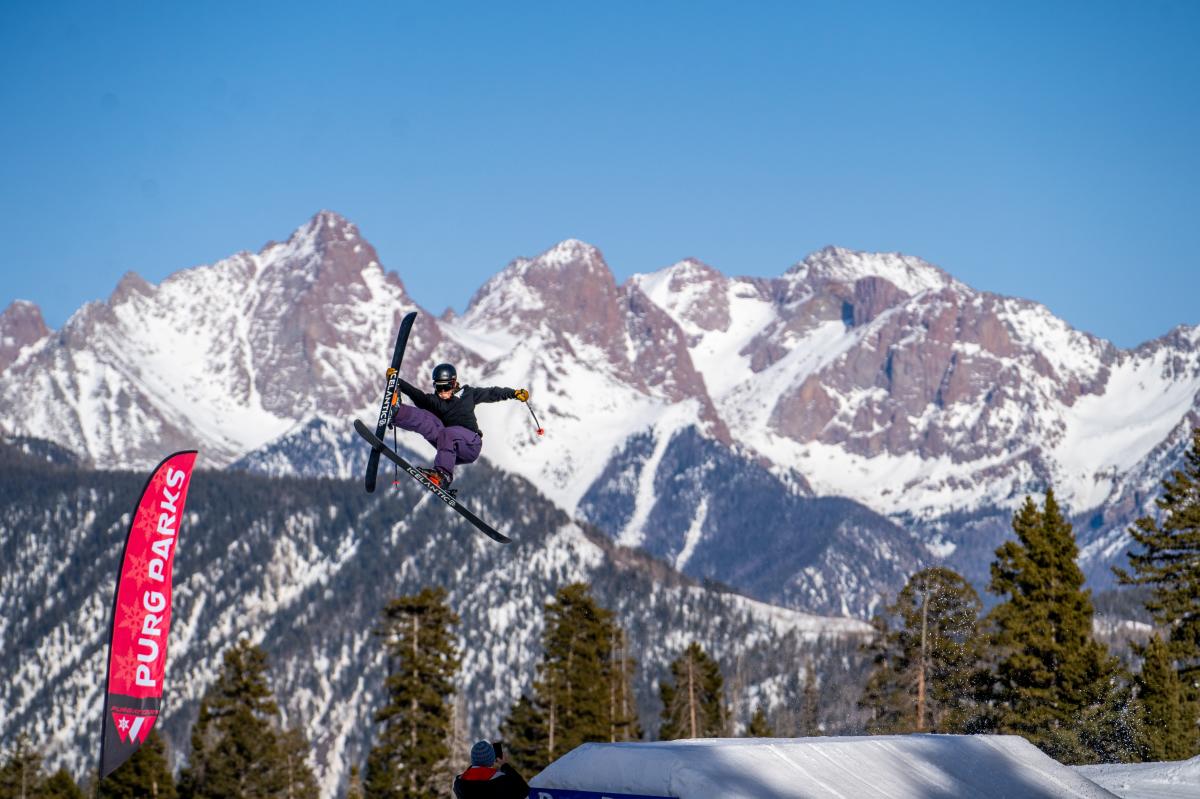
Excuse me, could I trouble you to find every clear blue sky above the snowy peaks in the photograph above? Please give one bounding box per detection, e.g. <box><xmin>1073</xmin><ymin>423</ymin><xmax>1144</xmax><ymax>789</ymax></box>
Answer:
<box><xmin>0</xmin><ymin>0</ymin><xmax>1200</xmax><ymax>346</ymax></box>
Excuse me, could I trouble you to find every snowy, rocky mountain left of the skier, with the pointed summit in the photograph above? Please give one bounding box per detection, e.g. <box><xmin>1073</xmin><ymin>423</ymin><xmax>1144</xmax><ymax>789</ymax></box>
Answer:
<box><xmin>0</xmin><ymin>212</ymin><xmax>451</xmax><ymax>467</ymax></box>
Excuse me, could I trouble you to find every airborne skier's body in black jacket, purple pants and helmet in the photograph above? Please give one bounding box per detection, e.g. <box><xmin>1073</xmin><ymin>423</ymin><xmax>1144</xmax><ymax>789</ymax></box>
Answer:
<box><xmin>388</xmin><ymin>364</ymin><xmax>529</xmax><ymax>489</ymax></box>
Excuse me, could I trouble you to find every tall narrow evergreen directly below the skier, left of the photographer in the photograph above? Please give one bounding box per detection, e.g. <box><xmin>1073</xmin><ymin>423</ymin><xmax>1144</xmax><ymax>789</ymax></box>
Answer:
<box><xmin>364</xmin><ymin>588</ymin><xmax>458</xmax><ymax>799</ymax></box>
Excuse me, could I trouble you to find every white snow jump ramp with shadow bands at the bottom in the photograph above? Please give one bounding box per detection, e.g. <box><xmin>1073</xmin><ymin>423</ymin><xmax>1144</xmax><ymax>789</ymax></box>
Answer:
<box><xmin>529</xmin><ymin>735</ymin><xmax>1116</xmax><ymax>799</ymax></box>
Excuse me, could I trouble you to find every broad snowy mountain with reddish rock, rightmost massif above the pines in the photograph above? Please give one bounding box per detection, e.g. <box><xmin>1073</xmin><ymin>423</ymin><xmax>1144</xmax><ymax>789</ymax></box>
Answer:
<box><xmin>631</xmin><ymin>247</ymin><xmax>1200</xmax><ymax>572</ymax></box>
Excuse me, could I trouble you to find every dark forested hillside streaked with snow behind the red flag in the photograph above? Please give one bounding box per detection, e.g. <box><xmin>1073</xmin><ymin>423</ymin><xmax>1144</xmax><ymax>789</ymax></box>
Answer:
<box><xmin>0</xmin><ymin>439</ymin><xmax>868</xmax><ymax>797</ymax></box>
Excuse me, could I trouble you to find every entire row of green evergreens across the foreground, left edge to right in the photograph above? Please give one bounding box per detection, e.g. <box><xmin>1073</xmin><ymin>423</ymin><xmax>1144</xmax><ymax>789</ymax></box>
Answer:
<box><xmin>0</xmin><ymin>431</ymin><xmax>1200</xmax><ymax>799</ymax></box>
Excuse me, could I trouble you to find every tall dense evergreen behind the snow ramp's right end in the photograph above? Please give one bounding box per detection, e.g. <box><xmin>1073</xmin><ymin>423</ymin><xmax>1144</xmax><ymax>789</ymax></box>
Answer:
<box><xmin>989</xmin><ymin>491</ymin><xmax>1135</xmax><ymax>763</ymax></box>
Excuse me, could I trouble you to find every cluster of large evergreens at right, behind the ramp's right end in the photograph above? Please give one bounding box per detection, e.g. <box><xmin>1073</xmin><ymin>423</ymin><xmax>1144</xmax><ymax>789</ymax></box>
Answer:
<box><xmin>859</xmin><ymin>431</ymin><xmax>1200</xmax><ymax>763</ymax></box>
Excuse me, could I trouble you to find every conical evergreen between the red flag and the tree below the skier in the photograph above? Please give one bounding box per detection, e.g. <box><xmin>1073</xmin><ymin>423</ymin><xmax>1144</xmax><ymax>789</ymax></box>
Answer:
<box><xmin>179</xmin><ymin>638</ymin><xmax>317</xmax><ymax>799</ymax></box>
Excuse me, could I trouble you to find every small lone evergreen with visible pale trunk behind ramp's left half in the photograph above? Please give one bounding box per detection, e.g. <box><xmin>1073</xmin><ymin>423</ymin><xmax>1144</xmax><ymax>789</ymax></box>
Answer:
<box><xmin>659</xmin><ymin>642</ymin><xmax>727</xmax><ymax>740</ymax></box>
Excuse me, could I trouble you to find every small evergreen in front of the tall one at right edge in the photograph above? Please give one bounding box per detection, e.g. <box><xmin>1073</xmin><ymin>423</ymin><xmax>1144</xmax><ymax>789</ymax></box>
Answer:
<box><xmin>1138</xmin><ymin>635</ymin><xmax>1192</xmax><ymax>761</ymax></box>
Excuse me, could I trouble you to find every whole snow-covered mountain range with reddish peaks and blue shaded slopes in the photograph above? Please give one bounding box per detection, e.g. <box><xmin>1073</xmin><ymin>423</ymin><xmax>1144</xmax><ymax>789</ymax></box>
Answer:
<box><xmin>0</xmin><ymin>211</ymin><xmax>1200</xmax><ymax>604</ymax></box>
